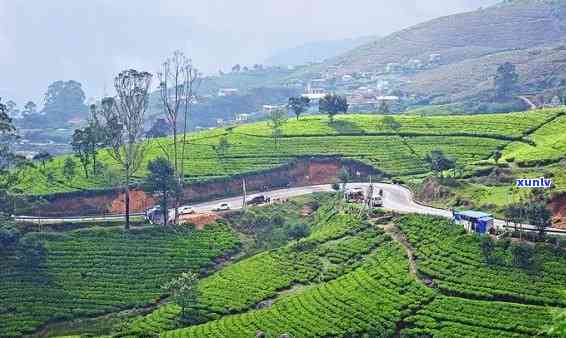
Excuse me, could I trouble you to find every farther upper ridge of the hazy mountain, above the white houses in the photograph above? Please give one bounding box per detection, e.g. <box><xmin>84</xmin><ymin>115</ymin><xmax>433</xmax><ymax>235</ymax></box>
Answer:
<box><xmin>316</xmin><ymin>0</ymin><xmax>566</xmax><ymax>72</ymax></box>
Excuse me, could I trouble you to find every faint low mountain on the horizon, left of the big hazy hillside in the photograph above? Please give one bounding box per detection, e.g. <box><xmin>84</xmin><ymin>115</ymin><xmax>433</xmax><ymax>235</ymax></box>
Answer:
<box><xmin>265</xmin><ymin>36</ymin><xmax>378</xmax><ymax>66</ymax></box>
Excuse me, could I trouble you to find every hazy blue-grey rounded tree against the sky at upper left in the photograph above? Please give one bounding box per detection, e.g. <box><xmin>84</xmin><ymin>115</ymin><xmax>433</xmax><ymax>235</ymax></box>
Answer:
<box><xmin>42</xmin><ymin>80</ymin><xmax>88</xmax><ymax>124</ymax></box>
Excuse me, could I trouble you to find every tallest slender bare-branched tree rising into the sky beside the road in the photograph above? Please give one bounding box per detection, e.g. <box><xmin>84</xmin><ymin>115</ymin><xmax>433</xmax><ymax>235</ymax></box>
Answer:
<box><xmin>157</xmin><ymin>51</ymin><xmax>199</xmax><ymax>223</ymax></box>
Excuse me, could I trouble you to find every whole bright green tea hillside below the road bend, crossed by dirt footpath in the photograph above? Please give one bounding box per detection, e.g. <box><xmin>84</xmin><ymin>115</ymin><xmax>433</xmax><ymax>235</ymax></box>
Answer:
<box><xmin>117</xmin><ymin>211</ymin><xmax>566</xmax><ymax>337</ymax></box>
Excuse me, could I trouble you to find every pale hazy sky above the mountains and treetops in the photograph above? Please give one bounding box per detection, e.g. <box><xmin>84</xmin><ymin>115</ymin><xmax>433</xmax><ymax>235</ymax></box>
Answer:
<box><xmin>0</xmin><ymin>0</ymin><xmax>499</xmax><ymax>107</ymax></box>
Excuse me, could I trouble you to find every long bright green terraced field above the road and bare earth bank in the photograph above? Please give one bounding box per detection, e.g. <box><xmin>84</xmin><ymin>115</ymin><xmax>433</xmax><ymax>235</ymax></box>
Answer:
<box><xmin>15</xmin><ymin>110</ymin><xmax>559</xmax><ymax>194</ymax></box>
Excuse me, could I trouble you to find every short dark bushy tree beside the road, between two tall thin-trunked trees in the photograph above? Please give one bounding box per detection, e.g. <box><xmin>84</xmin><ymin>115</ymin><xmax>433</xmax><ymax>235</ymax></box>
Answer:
<box><xmin>146</xmin><ymin>157</ymin><xmax>180</xmax><ymax>226</ymax></box>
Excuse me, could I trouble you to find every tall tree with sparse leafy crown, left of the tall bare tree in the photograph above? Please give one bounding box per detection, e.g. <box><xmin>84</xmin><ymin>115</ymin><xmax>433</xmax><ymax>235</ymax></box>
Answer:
<box><xmin>101</xmin><ymin>69</ymin><xmax>153</xmax><ymax>229</ymax></box>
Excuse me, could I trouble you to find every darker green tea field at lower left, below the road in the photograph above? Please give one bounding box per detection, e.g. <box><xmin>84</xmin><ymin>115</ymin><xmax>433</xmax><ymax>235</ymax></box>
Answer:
<box><xmin>0</xmin><ymin>224</ymin><xmax>239</xmax><ymax>337</ymax></box>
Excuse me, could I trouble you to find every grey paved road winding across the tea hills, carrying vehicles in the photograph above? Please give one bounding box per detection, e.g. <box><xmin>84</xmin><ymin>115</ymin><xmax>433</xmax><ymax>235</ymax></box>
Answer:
<box><xmin>16</xmin><ymin>183</ymin><xmax>566</xmax><ymax>235</ymax></box>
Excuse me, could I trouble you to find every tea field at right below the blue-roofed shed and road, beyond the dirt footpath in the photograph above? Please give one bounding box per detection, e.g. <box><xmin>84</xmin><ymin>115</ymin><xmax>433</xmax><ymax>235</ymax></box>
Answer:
<box><xmin>398</xmin><ymin>216</ymin><xmax>566</xmax><ymax>306</ymax></box>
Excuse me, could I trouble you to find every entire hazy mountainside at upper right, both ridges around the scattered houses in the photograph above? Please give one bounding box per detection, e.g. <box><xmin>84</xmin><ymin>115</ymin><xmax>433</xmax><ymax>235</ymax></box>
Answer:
<box><xmin>294</xmin><ymin>0</ymin><xmax>566</xmax><ymax>103</ymax></box>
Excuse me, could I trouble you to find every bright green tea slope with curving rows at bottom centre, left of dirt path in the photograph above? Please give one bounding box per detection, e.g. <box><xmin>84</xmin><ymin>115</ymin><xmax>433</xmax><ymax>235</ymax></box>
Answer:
<box><xmin>163</xmin><ymin>243</ymin><xmax>432</xmax><ymax>337</ymax></box>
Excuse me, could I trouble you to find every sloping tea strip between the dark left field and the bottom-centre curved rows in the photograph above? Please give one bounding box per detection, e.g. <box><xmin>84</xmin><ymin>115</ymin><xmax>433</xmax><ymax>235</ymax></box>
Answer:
<box><xmin>127</xmin><ymin>210</ymin><xmax>390</xmax><ymax>334</ymax></box>
